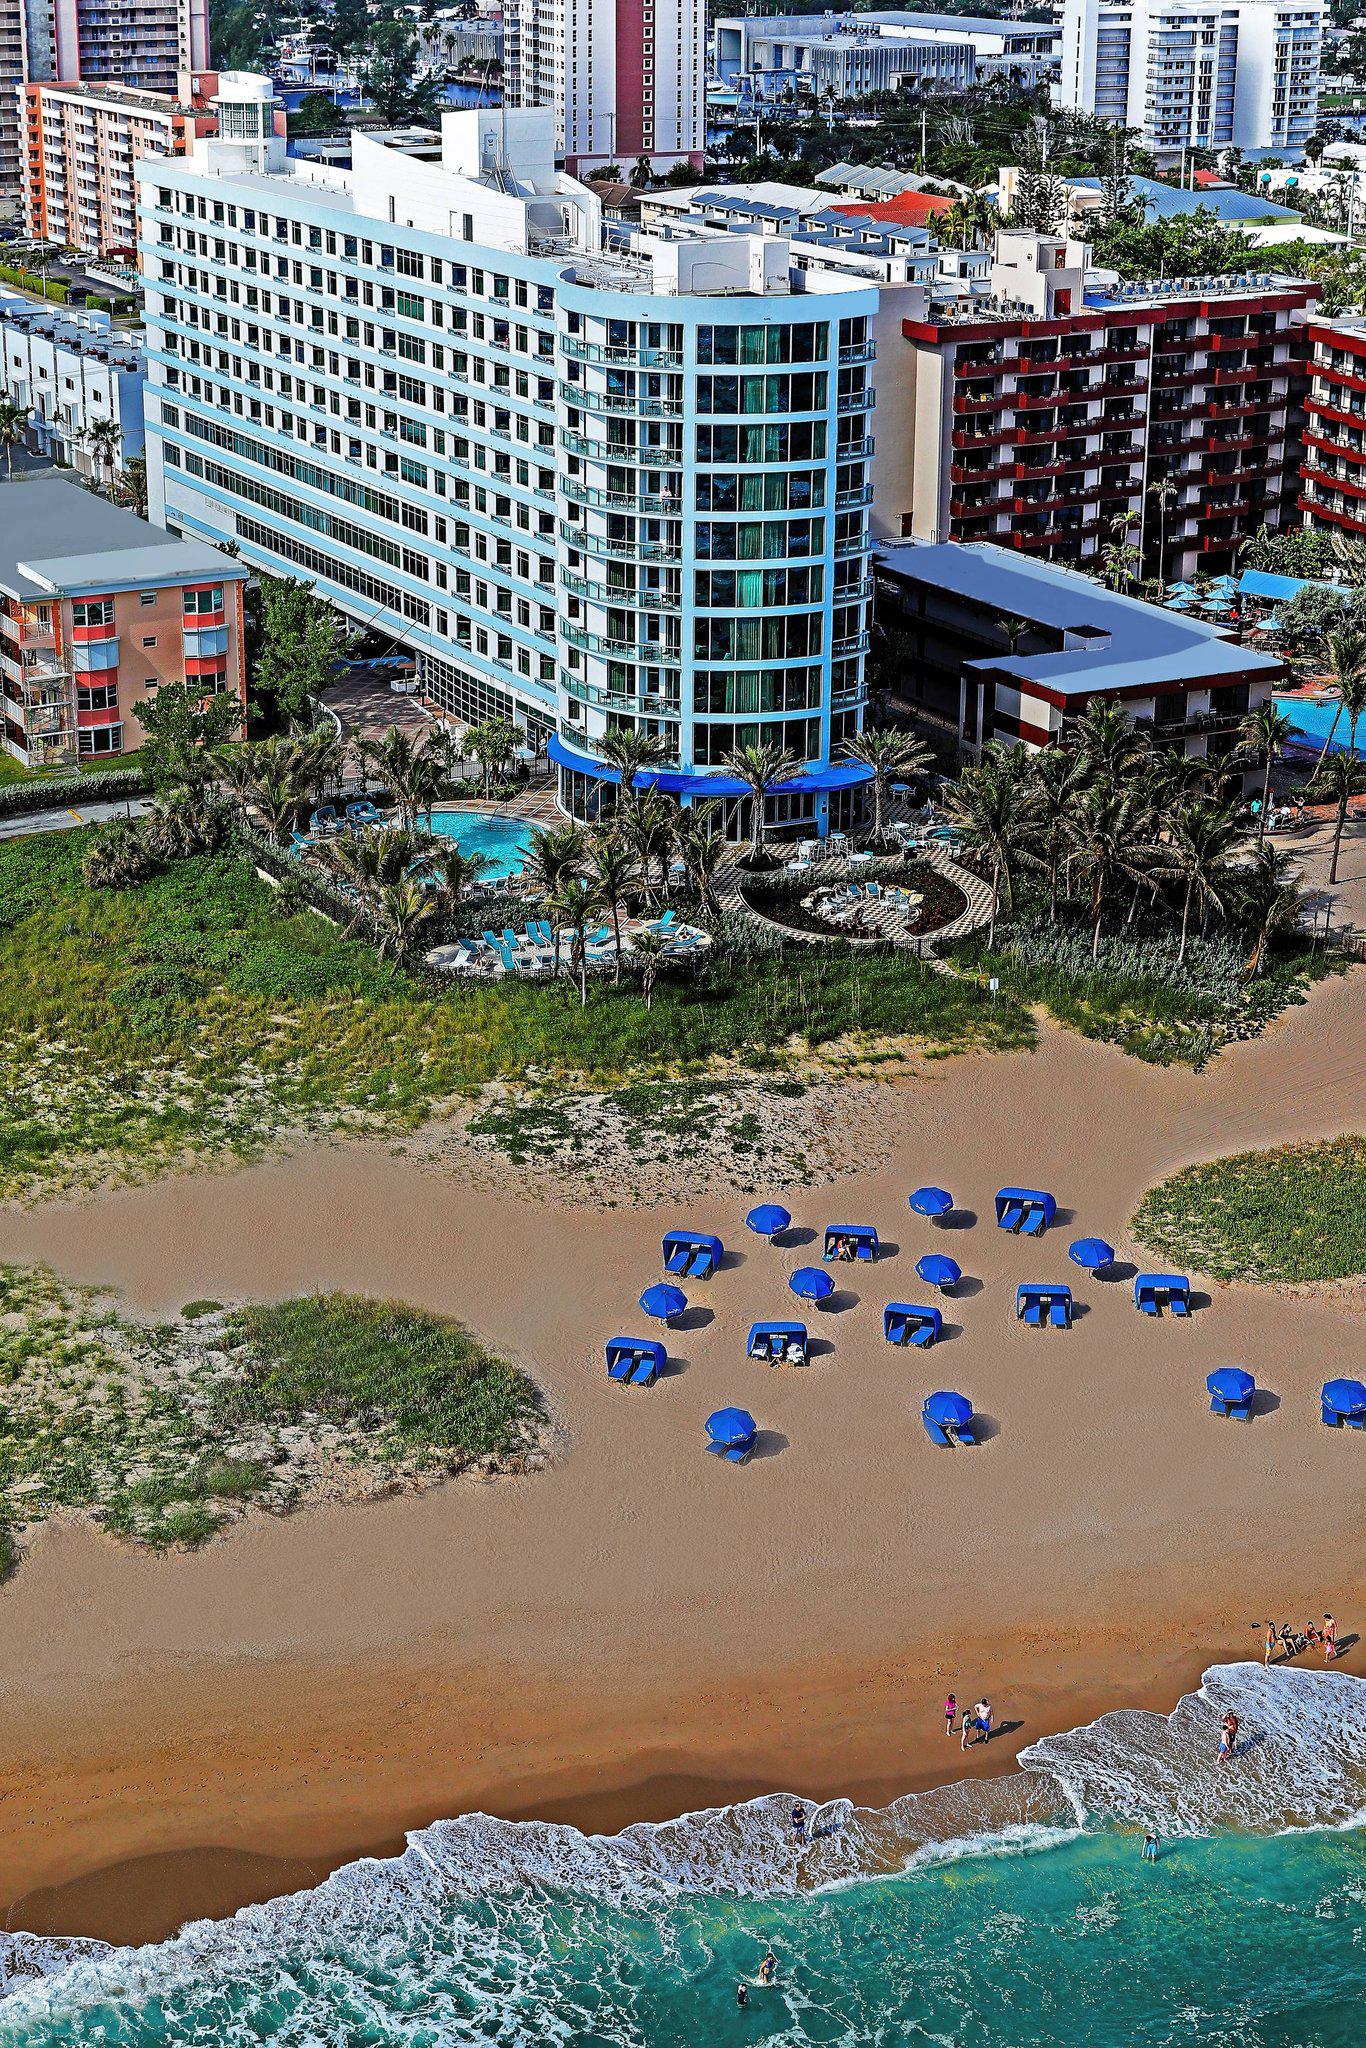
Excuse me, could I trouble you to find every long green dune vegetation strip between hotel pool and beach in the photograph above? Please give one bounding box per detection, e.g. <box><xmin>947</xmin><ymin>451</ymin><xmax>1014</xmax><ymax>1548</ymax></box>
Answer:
<box><xmin>0</xmin><ymin>831</ymin><xmax>1032</xmax><ymax>1194</ymax></box>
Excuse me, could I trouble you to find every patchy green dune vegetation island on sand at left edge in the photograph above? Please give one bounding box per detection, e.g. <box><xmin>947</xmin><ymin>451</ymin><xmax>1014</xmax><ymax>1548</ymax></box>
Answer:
<box><xmin>0</xmin><ymin>1266</ymin><xmax>541</xmax><ymax>1577</ymax></box>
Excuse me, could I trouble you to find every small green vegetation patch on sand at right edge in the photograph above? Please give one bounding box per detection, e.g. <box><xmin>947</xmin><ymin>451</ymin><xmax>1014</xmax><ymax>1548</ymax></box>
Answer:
<box><xmin>1135</xmin><ymin>1137</ymin><xmax>1366</xmax><ymax>1280</ymax></box>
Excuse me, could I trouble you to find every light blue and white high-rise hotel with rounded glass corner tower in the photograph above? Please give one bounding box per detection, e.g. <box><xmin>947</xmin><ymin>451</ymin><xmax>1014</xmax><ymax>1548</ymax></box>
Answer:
<box><xmin>139</xmin><ymin>76</ymin><xmax>879</xmax><ymax>829</ymax></box>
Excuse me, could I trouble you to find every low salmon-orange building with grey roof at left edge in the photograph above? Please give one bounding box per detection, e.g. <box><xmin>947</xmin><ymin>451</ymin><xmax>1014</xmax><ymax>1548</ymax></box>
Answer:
<box><xmin>0</xmin><ymin>477</ymin><xmax>248</xmax><ymax>768</ymax></box>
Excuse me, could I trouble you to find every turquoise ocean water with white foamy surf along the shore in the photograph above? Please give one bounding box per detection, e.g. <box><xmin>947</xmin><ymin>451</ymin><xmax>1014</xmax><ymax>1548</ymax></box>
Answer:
<box><xmin>0</xmin><ymin>1665</ymin><xmax>1366</xmax><ymax>2048</ymax></box>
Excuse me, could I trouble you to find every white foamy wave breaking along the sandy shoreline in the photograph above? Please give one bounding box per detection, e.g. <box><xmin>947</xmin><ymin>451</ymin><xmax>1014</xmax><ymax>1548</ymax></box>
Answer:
<box><xmin>0</xmin><ymin>1665</ymin><xmax>1366</xmax><ymax>2042</ymax></box>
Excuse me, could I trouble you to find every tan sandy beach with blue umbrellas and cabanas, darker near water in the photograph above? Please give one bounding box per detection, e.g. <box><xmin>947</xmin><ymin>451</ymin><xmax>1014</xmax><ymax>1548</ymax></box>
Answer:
<box><xmin>0</xmin><ymin>975</ymin><xmax>1366</xmax><ymax>1939</ymax></box>
